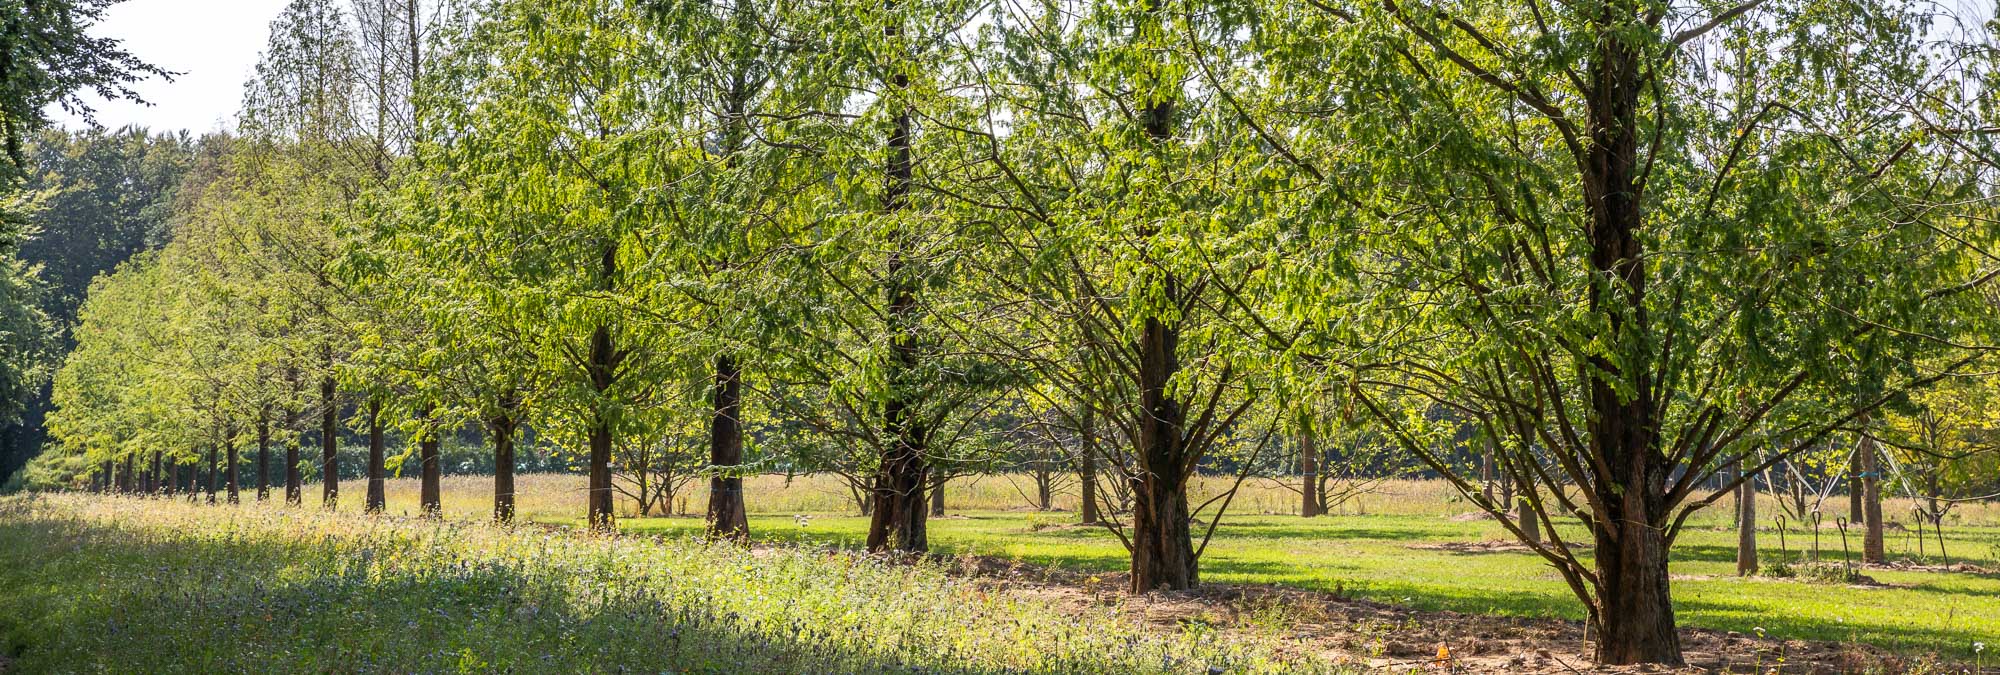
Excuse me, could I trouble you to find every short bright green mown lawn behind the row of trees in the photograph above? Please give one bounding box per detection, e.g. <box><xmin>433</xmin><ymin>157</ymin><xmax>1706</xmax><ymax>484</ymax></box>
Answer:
<box><xmin>604</xmin><ymin>511</ymin><xmax>2000</xmax><ymax>659</ymax></box>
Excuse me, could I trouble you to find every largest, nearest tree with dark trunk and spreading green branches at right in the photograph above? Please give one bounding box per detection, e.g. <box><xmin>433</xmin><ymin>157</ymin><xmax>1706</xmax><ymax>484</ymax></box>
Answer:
<box><xmin>1242</xmin><ymin>0</ymin><xmax>1994</xmax><ymax>663</ymax></box>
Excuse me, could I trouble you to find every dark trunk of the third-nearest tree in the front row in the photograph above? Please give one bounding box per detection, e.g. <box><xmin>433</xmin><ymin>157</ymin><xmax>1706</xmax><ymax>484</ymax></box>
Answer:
<box><xmin>868</xmin><ymin>9</ymin><xmax>930</xmax><ymax>551</ymax></box>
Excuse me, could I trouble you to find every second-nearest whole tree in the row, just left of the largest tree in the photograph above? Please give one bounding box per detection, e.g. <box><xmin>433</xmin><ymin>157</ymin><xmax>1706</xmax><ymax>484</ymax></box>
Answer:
<box><xmin>926</xmin><ymin>0</ymin><xmax>1288</xmax><ymax>591</ymax></box>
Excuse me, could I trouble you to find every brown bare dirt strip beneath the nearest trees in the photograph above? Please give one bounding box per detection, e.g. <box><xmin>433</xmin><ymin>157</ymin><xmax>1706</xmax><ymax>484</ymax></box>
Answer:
<box><xmin>954</xmin><ymin>557</ymin><xmax>1976</xmax><ymax>673</ymax></box>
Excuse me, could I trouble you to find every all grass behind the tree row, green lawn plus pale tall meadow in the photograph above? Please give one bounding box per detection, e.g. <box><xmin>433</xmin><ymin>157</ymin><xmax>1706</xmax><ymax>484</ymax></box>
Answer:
<box><xmin>316</xmin><ymin>475</ymin><xmax>2000</xmax><ymax>659</ymax></box>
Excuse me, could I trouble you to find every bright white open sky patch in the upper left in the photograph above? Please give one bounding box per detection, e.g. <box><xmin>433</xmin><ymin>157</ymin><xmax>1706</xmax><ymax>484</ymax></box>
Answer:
<box><xmin>50</xmin><ymin>0</ymin><xmax>286</xmax><ymax>134</ymax></box>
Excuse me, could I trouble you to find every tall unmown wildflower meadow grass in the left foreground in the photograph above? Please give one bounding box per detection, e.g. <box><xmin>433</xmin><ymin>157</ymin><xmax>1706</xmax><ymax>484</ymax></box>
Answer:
<box><xmin>0</xmin><ymin>495</ymin><xmax>1332</xmax><ymax>673</ymax></box>
